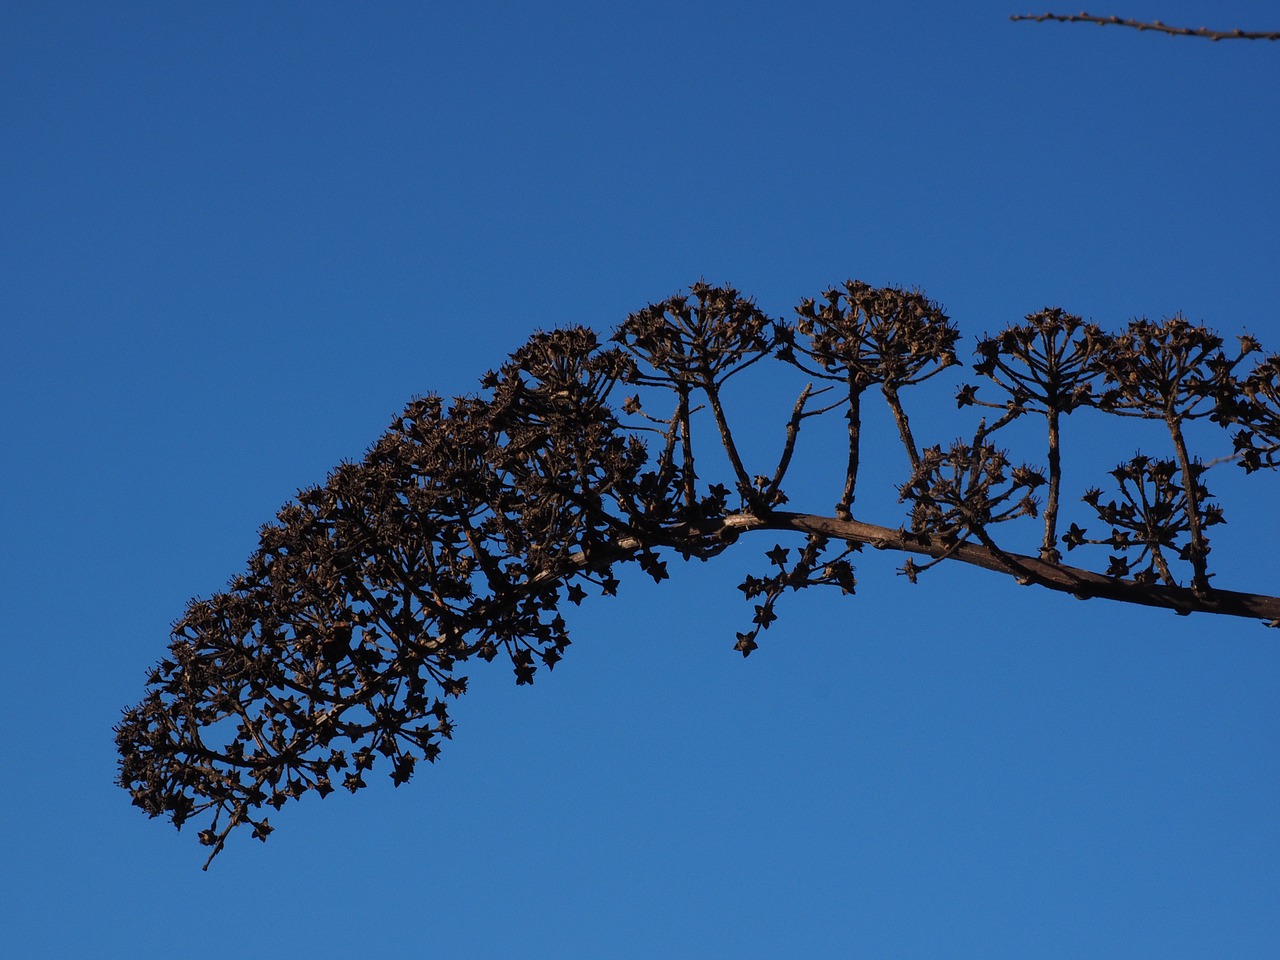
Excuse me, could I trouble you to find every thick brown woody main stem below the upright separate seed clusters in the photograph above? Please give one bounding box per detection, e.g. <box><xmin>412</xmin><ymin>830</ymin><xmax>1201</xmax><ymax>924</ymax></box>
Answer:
<box><xmin>724</xmin><ymin>511</ymin><xmax>1280</xmax><ymax>626</ymax></box>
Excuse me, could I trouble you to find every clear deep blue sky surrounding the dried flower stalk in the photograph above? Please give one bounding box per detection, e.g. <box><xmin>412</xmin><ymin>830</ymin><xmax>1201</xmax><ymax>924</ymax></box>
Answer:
<box><xmin>0</xmin><ymin>0</ymin><xmax>1280</xmax><ymax>960</ymax></box>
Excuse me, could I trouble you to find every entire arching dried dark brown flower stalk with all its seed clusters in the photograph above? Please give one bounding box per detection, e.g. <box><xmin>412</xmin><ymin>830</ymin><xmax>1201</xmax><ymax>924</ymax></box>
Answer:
<box><xmin>116</xmin><ymin>280</ymin><xmax>1280</xmax><ymax>865</ymax></box>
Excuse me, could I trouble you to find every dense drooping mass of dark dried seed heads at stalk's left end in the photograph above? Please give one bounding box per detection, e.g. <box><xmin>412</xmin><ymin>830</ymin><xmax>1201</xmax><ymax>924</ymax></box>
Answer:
<box><xmin>116</xmin><ymin>329</ymin><xmax>695</xmax><ymax>870</ymax></box>
